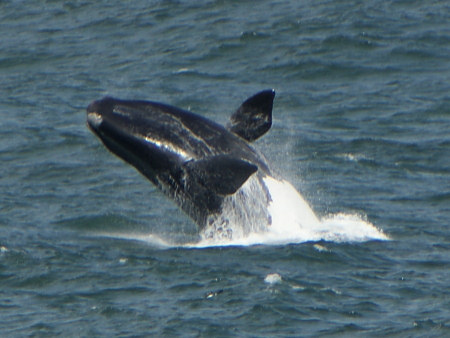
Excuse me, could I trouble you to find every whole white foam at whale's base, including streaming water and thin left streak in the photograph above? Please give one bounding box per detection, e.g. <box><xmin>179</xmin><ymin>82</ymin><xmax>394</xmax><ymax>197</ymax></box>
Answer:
<box><xmin>97</xmin><ymin>176</ymin><xmax>389</xmax><ymax>248</ymax></box>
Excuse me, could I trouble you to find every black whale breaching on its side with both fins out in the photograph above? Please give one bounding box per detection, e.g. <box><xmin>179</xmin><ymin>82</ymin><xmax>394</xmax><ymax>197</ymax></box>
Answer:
<box><xmin>87</xmin><ymin>90</ymin><xmax>284</xmax><ymax>236</ymax></box>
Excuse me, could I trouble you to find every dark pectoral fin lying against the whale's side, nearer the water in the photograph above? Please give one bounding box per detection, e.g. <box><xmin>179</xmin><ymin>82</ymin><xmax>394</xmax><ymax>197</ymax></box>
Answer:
<box><xmin>184</xmin><ymin>155</ymin><xmax>258</xmax><ymax>195</ymax></box>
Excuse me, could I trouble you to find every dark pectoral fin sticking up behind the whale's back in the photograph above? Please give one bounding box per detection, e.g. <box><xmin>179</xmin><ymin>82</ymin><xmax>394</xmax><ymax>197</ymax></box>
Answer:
<box><xmin>228</xmin><ymin>89</ymin><xmax>275</xmax><ymax>142</ymax></box>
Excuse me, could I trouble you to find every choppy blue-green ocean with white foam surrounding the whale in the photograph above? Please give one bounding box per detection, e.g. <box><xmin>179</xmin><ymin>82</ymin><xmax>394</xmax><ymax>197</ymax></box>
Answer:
<box><xmin>0</xmin><ymin>0</ymin><xmax>450</xmax><ymax>337</ymax></box>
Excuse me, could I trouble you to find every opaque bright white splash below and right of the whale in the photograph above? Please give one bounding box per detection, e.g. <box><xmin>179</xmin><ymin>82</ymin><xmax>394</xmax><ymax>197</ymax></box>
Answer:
<box><xmin>193</xmin><ymin>176</ymin><xmax>389</xmax><ymax>247</ymax></box>
